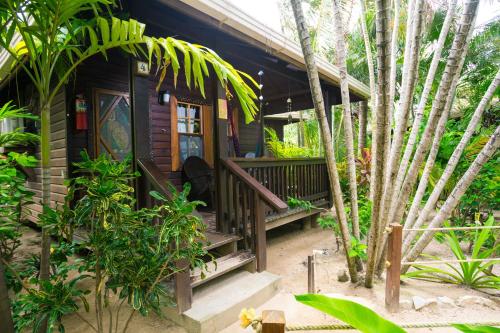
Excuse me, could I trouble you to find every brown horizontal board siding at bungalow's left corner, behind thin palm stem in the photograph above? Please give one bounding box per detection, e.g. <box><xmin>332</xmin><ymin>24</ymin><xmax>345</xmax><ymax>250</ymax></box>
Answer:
<box><xmin>25</xmin><ymin>89</ymin><xmax>68</xmax><ymax>222</ymax></box>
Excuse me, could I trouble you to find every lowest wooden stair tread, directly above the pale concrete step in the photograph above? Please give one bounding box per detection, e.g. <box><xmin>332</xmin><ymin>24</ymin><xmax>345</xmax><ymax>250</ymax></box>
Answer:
<box><xmin>191</xmin><ymin>250</ymin><xmax>255</xmax><ymax>288</ymax></box>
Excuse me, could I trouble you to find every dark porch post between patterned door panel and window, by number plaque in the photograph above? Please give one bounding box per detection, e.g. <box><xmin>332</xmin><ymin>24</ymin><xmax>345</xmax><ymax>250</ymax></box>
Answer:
<box><xmin>129</xmin><ymin>58</ymin><xmax>152</xmax><ymax>207</ymax></box>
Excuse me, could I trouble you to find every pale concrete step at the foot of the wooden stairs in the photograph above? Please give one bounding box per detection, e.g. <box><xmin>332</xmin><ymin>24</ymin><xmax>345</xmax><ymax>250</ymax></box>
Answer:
<box><xmin>166</xmin><ymin>270</ymin><xmax>281</xmax><ymax>333</ymax></box>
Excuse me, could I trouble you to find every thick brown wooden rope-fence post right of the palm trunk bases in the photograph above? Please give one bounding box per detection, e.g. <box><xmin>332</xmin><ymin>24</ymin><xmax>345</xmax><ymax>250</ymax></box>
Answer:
<box><xmin>385</xmin><ymin>223</ymin><xmax>403</xmax><ymax>312</ymax></box>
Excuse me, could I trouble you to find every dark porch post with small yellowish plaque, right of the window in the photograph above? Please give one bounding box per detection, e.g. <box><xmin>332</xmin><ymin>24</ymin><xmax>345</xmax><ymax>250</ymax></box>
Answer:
<box><xmin>212</xmin><ymin>79</ymin><xmax>229</xmax><ymax>233</ymax></box>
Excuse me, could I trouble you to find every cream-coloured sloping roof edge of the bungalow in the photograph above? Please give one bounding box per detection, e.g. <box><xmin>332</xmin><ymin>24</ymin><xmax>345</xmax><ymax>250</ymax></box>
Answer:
<box><xmin>172</xmin><ymin>0</ymin><xmax>370</xmax><ymax>99</ymax></box>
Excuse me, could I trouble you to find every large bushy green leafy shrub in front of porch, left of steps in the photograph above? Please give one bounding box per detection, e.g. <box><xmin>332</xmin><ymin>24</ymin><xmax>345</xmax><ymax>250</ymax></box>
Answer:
<box><xmin>60</xmin><ymin>152</ymin><xmax>206</xmax><ymax>333</ymax></box>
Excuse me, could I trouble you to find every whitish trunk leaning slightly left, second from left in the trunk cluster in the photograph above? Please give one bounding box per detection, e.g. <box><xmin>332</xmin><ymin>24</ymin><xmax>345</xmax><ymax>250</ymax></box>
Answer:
<box><xmin>332</xmin><ymin>0</ymin><xmax>361</xmax><ymax>246</ymax></box>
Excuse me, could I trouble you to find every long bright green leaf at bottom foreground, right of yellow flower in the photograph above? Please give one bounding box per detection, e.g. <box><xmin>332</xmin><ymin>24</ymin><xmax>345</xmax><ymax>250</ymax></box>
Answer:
<box><xmin>295</xmin><ymin>294</ymin><xmax>406</xmax><ymax>333</ymax></box>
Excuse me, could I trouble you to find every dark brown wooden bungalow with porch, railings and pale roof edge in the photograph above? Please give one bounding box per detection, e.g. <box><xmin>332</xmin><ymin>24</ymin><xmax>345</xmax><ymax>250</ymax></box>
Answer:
<box><xmin>0</xmin><ymin>0</ymin><xmax>369</xmax><ymax>324</ymax></box>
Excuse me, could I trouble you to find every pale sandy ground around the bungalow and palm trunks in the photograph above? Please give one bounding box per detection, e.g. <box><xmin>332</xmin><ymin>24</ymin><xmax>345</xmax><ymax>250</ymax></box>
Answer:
<box><xmin>11</xmin><ymin>224</ymin><xmax>500</xmax><ymax>333</ymax></box>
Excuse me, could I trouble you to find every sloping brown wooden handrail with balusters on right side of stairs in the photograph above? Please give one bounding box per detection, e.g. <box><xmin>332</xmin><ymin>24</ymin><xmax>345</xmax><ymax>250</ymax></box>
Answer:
<box><xmin>218</xmin><ymin>160</ymin><xmax>288</xmax><ymax>272</ymax></box>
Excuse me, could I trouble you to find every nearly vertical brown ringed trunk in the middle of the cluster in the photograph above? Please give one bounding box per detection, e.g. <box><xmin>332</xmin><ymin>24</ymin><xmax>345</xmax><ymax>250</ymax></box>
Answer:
<box><xmin>365</xmin><ymin>0</ymin><xmax>391</xmax><ymax>288</ymax></box>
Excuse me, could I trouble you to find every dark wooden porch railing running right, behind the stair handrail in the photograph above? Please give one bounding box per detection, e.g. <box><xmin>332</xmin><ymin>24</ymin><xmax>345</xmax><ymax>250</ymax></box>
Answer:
<box><xmin>232</xmin><ymin>158</ymin><xmax>330</xmax><ymax>202</ymax></box>
